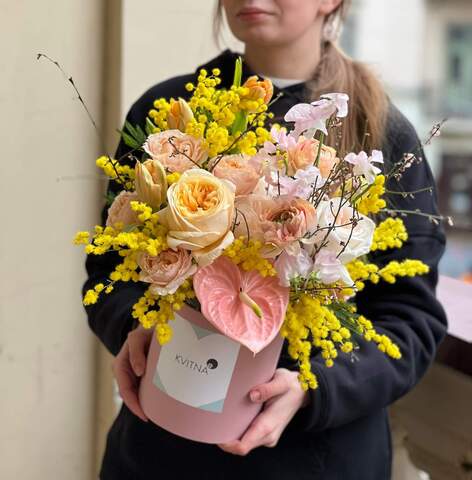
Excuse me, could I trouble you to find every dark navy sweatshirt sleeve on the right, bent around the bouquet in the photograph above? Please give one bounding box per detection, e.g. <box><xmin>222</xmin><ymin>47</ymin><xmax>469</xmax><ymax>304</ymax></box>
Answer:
<box><xmin>293</xmin><ymin>107</ymin><xmax>447</xmax><ymax>432</ymax></box>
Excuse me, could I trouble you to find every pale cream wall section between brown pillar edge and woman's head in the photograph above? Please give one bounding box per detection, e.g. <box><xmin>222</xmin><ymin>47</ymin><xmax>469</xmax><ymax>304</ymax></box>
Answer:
<box><xmin>122</xmin><ymin>0</ymin><xmax>240</xmax><ymax>118</ymax></box>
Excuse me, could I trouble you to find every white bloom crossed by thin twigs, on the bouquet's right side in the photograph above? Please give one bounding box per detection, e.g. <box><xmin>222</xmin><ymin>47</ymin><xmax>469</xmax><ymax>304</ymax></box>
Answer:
<box><xmin>312</xmin><ymin>197</ymin><xmax>375</xmax><ymax>264</ymax></box>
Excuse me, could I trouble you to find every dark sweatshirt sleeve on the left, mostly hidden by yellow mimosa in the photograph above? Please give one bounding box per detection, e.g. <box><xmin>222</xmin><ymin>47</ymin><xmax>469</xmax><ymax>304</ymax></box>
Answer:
<box><xmin>82</xmin><ymin>104</ymin><xmax>146</xmax><ymax>355</ymax></box>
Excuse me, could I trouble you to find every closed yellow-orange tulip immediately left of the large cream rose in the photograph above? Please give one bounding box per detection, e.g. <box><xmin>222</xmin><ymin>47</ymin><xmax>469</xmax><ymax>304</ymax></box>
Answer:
<box><xmin>134</xmin><ymin>160</ymin><xmax>167</xmax><ymax>209</ymax></box>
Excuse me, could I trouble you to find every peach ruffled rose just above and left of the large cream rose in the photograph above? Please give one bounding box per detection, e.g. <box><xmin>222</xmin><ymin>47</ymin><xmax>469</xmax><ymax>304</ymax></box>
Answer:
<box><xmin>143</xmin><ymin>130</ymin><xmax>208</xmax><ymax>173</ymax></box>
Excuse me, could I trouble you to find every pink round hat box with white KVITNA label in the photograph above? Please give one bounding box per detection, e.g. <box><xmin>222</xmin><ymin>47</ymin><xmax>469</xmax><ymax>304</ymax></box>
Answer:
<box><xmin>139</xmin><ymin>305</ymin><xmax>283</xmax><ymax>444</ymax></box>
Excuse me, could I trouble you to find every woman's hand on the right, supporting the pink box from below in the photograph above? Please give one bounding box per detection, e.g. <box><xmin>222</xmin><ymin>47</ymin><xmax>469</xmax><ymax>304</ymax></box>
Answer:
<box><xmin>218</xmin><ymin>368</ymin><xmax>309</xmax><ymax>455</ymax></box>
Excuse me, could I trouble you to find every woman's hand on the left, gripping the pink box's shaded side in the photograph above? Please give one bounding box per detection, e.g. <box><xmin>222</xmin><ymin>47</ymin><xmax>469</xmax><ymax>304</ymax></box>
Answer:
<box><xmin>113</xmin><ymin>326</ymin><xmax>153</xmax><ymax>422</ymax></box>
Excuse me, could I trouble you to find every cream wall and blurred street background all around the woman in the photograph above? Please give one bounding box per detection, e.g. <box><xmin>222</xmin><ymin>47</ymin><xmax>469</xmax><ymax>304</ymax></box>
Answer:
<box><xmin>0</xmin><ymin>0</ymin><xmax>472</xmax><ymax>480</ymax></box>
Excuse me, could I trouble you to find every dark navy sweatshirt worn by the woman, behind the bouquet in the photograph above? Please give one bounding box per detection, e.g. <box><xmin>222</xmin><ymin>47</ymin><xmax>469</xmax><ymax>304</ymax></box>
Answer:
<box><xmin>83</xmin><ymin>47</ymin><xmax>446</xmax><ymax>480</ymax></box>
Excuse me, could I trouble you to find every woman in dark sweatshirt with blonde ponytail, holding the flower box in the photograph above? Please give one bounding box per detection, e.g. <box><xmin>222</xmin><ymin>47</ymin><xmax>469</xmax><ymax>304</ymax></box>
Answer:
<box><xmin>84</xmin><ymin>0</ymin><xmax>446</xmax><ymax>480</ymax></box>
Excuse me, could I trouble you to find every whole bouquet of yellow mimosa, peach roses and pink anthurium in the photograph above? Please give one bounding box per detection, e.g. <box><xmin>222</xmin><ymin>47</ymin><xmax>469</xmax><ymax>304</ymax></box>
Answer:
<box><xmin>75</xmin><ymin>61</ymin><xmax>434</xmax><ymax>389</ymax></box>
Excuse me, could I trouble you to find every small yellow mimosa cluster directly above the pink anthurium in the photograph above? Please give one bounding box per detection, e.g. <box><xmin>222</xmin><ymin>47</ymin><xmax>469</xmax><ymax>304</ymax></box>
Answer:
<box><xmin>223</xmin><ymin>237</ymin><xmax>277</xmax><ymax>277</ymax></box>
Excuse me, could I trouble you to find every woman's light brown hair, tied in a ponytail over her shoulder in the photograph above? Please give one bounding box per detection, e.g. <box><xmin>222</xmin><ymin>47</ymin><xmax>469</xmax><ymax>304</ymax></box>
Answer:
<box><xmin>213</xmin><ymin>0</ymin><xmax>388</xmax><ymax>153</ymax></box>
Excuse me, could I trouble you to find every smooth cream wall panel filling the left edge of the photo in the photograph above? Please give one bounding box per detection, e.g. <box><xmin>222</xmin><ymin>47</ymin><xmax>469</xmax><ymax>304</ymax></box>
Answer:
<box><xmin>0</xmin><ymin>0</ymin><xmax>103</xmax><ymax>480</ymax></box>
